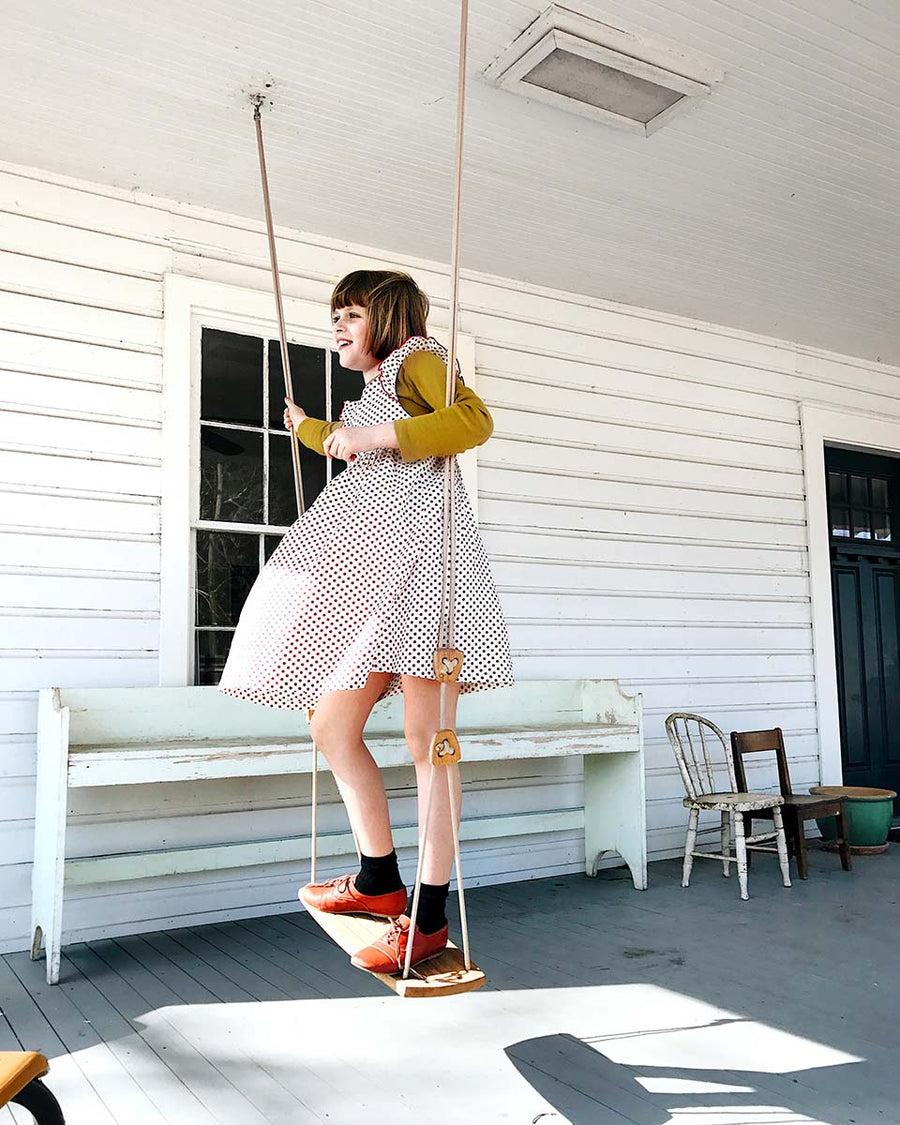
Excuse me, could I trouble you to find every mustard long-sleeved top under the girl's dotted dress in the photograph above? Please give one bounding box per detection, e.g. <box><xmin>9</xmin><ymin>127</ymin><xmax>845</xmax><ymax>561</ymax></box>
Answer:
<box><xmin>297</xmin><ymin>351</ymin><xmax>494</xmax><ymax>461</ymax></box>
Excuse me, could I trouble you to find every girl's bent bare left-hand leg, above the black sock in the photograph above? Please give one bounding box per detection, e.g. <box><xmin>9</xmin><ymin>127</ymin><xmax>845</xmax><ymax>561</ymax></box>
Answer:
<box><xmin>309</xmin><ymin>672</ymin><xmax>394</xmax><ymax>856</ymax></box>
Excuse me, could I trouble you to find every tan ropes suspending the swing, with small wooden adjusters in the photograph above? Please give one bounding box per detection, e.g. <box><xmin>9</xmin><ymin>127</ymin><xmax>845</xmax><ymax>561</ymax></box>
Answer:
<box><xmin>251</xmin><ymin>0</ymin><xmax>471</xmax><ymax>980</ymax></box>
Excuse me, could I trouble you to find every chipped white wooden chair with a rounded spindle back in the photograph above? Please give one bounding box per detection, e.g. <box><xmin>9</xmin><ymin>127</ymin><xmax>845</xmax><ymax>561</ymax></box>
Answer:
<box><xmin>666</xmin><ymin>711</ymin><xmax>791</xmax><ymax>899</ymax></box>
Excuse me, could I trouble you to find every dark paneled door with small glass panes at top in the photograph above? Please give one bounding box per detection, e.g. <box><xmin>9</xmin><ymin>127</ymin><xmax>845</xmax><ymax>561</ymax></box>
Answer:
<box><xmin>825</xmin><ymin>449</ymin><xmax>900</xmax><ymax>791</ymax></box>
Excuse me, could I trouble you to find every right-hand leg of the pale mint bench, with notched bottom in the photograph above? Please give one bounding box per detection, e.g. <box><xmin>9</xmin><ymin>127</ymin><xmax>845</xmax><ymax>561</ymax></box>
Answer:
<box><xmin>584</xmin><ymin>753</ymin><xmax>647</xmax><ymax>891</ymax></box>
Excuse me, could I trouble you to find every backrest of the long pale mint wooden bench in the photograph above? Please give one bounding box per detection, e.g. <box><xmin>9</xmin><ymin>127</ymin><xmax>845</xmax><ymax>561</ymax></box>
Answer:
<box><xmin>56</xmin><ymin>680</ymin><xmax>639</xmax><ymax>746</ymax></box>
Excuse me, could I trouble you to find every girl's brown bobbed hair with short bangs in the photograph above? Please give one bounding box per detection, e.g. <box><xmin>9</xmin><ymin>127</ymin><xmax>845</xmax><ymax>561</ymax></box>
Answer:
<box><xmin>331</xmin><ymin>270</ymin><xmax>429</xmax><ymax>359</ymax></box>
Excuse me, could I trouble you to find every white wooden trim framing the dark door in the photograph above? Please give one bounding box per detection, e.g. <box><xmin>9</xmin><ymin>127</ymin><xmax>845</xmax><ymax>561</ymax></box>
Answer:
<box><xmin>800</xmin><ymin>404</ymin><xmax>900</xmax><ymax>785</ymax></box>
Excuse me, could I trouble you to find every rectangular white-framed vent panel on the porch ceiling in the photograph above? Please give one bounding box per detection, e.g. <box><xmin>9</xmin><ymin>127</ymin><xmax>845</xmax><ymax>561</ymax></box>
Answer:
<box><xmin>485</xmin><ymin>5</ymin><xmax>722</xmax><ymax>136</ymax></box>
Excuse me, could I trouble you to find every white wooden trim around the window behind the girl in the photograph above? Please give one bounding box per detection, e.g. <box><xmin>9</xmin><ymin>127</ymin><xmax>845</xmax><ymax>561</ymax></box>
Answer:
<box><xmin>159</xmin><ymin>273</ymin><xmax>486</xmax><ymax>686</ymax></box>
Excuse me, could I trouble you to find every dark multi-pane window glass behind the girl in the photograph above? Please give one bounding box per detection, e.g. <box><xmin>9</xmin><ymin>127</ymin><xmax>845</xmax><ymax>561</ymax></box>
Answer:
<box><xmin>194</xmin><ymin>327</ymin><xmax>362</xmax><ymax>684</ymax></box>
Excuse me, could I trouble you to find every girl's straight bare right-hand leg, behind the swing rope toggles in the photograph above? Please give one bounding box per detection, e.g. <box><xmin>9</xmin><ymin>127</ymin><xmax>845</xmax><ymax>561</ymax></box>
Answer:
<box><xmin>403</xmin><ymin>676</ymin><xmax>462</xmax><ymax>885</ymax></box>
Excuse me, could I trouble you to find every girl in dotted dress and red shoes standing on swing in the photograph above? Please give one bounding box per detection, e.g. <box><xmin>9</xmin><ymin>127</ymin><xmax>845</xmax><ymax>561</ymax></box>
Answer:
<box><xmin>219</xmin><ymin>270</ymin><xmax>513</xmax><ymax>972</ymax></box>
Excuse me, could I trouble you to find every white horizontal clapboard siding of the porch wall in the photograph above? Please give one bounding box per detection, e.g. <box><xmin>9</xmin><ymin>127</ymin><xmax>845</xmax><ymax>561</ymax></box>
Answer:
<box><xmin>0</xmin><ymin>167</ymin><xmax>900</xmax><ymax>948</ymax></box>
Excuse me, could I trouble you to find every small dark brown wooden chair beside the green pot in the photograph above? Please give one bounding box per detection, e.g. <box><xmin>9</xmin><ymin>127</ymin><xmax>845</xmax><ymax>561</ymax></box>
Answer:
<box><xmin>731</xmin><ymin>727</ymin><xmax>851</xmax><ymax>879</ymax></box>
